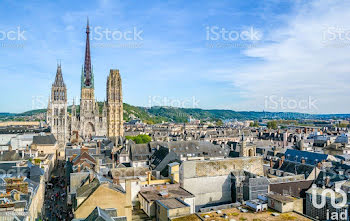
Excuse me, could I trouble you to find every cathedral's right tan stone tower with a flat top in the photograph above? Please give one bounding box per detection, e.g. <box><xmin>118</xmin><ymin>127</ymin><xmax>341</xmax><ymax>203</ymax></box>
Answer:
<box><xmin>107</xmin><ymin>70</ymin><xmax>124</xmax><ymax>138</ymax></box>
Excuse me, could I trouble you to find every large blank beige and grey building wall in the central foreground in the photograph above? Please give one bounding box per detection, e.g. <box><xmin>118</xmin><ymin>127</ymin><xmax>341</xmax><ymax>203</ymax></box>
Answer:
<box><xmin>180</xmin><ymin>157</ymin><xmax>263</xmax><ymax>211</ymax></box>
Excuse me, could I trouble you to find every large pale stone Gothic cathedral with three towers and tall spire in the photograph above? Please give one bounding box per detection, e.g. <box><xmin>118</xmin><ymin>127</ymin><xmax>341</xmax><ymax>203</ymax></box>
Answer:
<box><xmin>46</xmin><ymin>19</ymin><xmax>123</xmax><ymax>147</ymax></box>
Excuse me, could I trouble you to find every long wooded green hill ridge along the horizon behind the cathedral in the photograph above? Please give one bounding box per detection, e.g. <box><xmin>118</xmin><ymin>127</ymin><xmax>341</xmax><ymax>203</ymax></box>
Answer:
<box><xmin>0</xmin><ymin>102</ymin><xmax>350</xmax><ymax>124</ymax></box>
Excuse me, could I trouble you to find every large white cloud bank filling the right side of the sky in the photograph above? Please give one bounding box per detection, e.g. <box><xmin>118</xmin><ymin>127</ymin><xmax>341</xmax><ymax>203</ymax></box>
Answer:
<box><xmin>218</xmin><ymin>1</ymin><xmax>350</xmax><ymax>113</ymax></box>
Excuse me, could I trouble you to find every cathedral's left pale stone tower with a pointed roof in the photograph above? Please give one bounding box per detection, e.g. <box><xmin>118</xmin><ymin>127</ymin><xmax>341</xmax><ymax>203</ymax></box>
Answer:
<box><xmin>46</xmin><ymin>65</ymin><xmax>69</xmax><ymax>147</ymax></box>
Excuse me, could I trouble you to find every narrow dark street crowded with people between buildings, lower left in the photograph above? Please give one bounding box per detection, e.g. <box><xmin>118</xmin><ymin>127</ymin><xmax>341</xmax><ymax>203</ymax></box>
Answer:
<box><xmin>43</xmin><ymin>161</ymin><xmax>73</xmax><ymax>221</ymax></box>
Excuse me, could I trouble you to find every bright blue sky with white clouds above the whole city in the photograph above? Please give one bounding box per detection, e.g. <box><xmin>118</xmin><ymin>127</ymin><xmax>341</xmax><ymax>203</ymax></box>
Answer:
<box><xmin>0</xmin><ymin>0</ymin><xmax>350</xmax><ymax>113</ymax></box>
